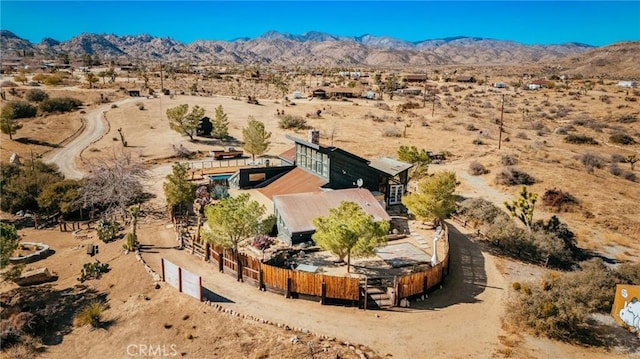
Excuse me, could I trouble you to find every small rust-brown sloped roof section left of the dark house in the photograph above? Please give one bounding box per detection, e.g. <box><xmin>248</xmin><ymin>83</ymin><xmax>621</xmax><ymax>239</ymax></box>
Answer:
<box><xmin>259</xmin><ymin>167</ymin><xmax>329</xmax><ymax>199</ymax></box>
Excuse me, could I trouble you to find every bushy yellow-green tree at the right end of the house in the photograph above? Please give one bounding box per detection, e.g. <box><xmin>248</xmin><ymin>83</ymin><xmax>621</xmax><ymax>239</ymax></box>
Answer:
<box><xmin>402</xmin><ymin>171</ymin><xmax>456</xmax><ymax>223</ymax></box>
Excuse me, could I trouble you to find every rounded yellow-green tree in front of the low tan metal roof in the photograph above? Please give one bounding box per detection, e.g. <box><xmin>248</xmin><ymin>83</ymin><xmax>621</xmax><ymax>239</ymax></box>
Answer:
<box><xmin>312</xmin><ymin>201</ymin><xmax>390</xmax><ymax>272</ymax></box>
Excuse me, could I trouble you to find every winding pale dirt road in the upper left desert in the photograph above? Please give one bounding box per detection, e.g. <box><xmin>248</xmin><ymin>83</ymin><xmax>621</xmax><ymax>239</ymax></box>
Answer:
<box><xmin>46</xmin><ymin>98</ymin><xmax>140</xmax><ymax>179</ymax></box>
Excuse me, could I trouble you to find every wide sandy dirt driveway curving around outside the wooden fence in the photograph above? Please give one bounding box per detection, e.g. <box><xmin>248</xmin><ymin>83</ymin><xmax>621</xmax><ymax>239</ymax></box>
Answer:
<box><xmin>141</xmin><ymin>221</ymin><xmax>505</xmax><ymax>358</ymax></box>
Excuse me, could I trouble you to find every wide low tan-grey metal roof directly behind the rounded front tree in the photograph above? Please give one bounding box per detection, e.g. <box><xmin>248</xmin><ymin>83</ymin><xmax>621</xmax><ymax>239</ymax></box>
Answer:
<box><xmin>273</xmin><ymin>188</ymin><xmax>391</xmax><ymax>233</ymax></box>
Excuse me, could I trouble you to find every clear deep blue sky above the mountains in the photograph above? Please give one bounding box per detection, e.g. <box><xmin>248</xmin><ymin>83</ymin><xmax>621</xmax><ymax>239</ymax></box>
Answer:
<box><xmin>0</xmin><ymin>0</ymin><xmax>640</xmax><ymax>46</ymax></box>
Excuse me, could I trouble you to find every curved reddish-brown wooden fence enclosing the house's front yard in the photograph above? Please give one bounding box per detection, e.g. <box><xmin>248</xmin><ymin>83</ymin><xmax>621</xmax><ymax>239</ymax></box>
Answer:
<box><xmin>176</xmin><ymin>221</ymin><xmax>449</xmax><ymax>305</ymax></box>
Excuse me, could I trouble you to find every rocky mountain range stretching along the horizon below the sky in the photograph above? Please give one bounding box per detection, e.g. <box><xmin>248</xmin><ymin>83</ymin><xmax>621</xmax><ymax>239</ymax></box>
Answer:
<box><xmin>0</xmin><ymin>30</ymin><xmax>634</xmax><ymax>76</ymax></box>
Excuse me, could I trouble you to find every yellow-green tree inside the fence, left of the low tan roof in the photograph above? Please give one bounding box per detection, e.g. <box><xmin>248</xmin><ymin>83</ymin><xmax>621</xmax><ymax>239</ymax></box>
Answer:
<box><xmin>202</xmin><ymin>193</ymin><xmax>266</xmax><ymax>281</ymax></box>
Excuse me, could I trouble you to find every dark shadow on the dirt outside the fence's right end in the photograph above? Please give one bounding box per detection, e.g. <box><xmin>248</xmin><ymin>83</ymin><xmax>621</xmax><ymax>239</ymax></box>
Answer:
<box><xmin>411</xmin><ymin>225</ymin><xmax>487</xmax><ymax>310</ymax></box>
